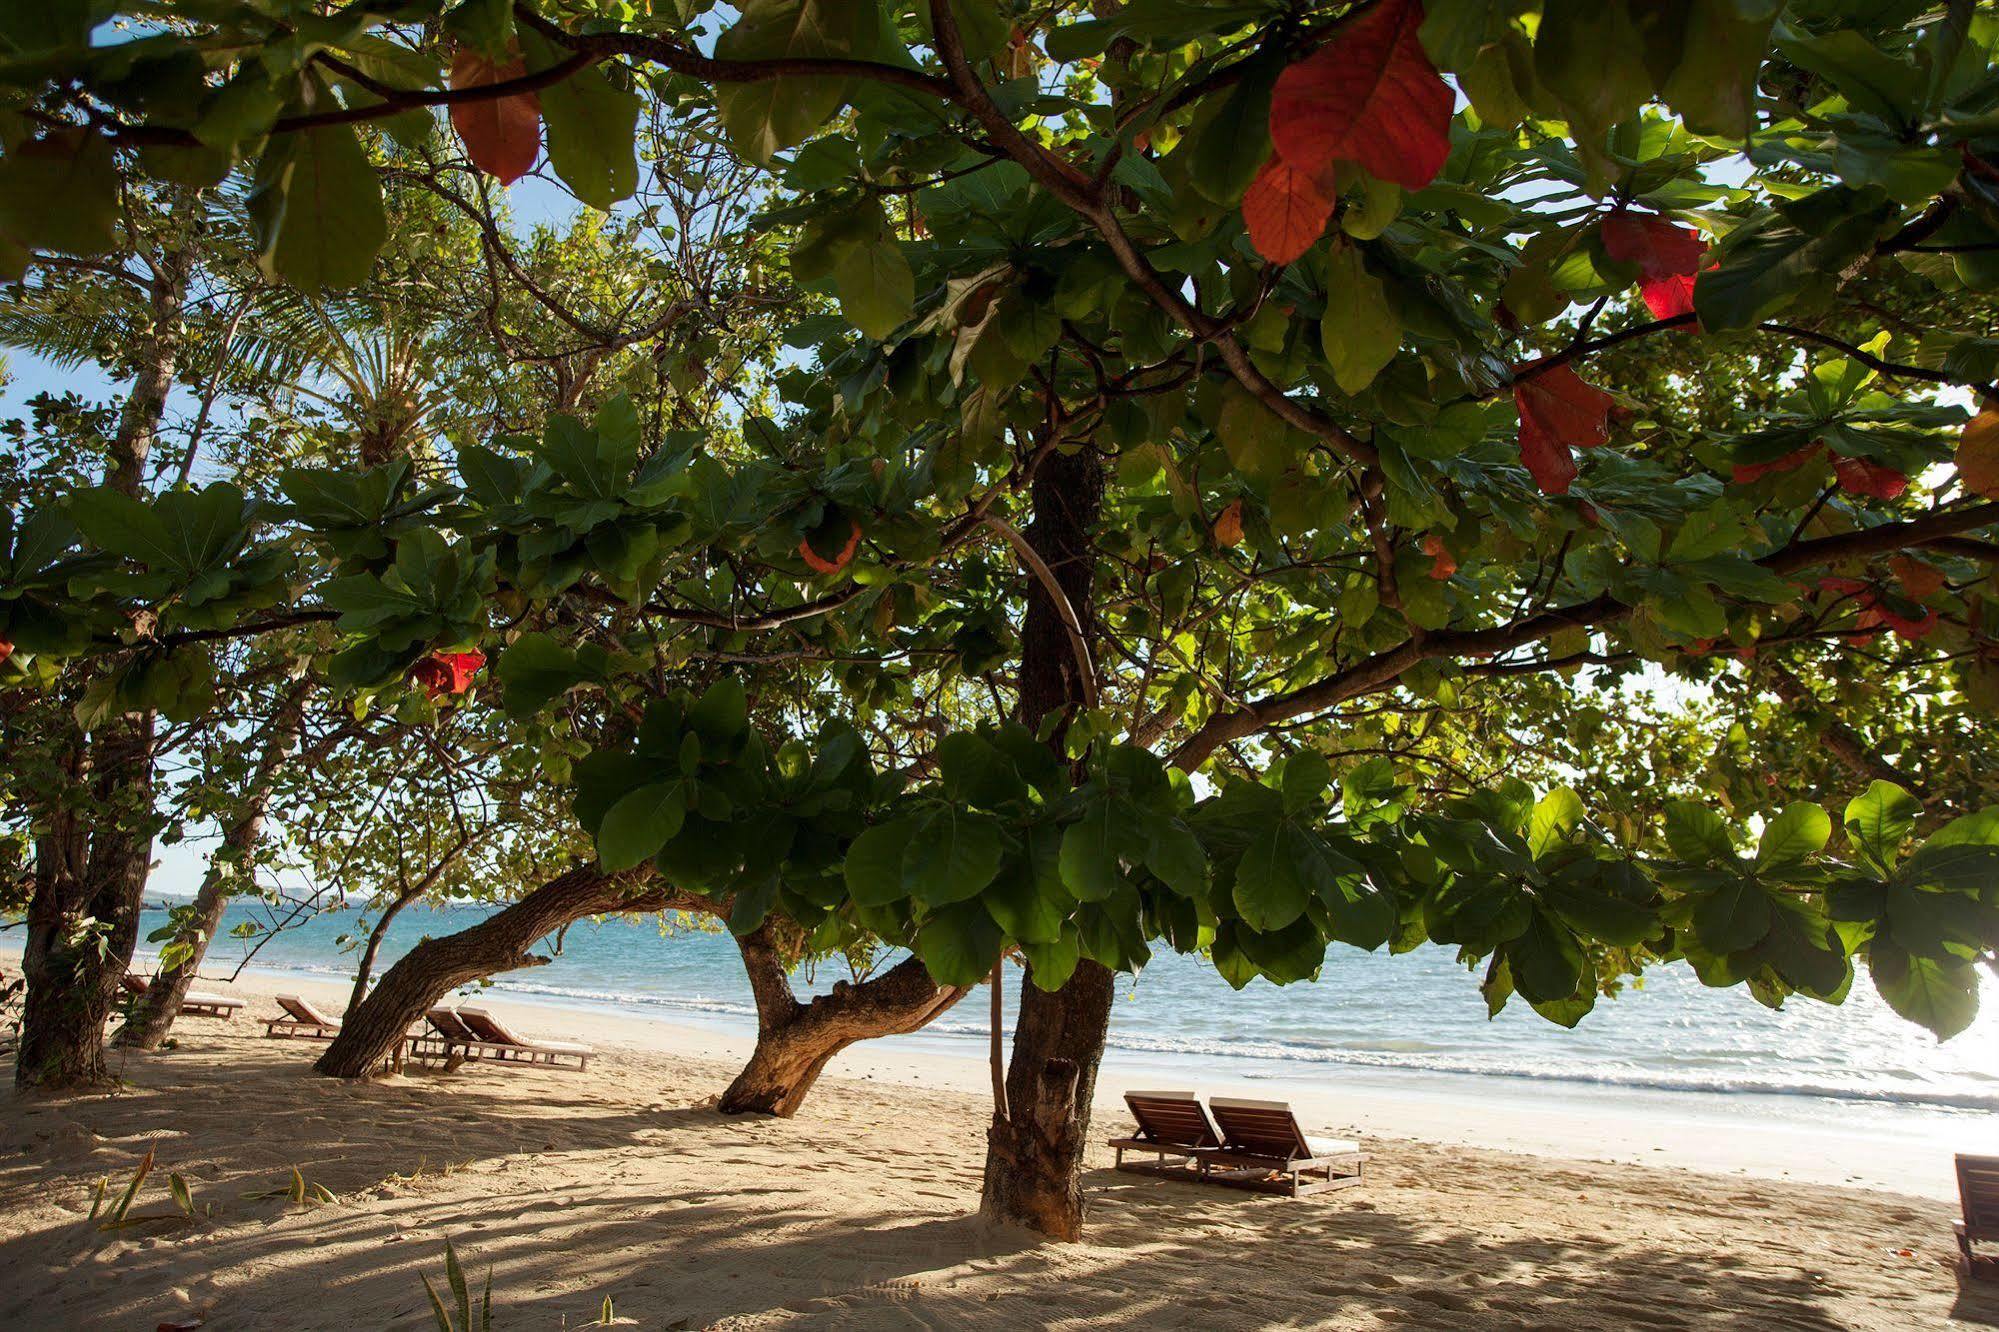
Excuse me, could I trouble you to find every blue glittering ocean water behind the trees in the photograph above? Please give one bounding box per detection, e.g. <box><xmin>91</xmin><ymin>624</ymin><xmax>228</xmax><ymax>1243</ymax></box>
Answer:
<box><xmin>140</xmin><ymin>888</ymin><xmax>1999</xmax><ymax>1114</ymax></box>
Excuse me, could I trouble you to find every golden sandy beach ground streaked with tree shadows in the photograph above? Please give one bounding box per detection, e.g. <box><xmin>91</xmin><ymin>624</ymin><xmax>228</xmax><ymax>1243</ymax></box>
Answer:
<box><xmin>0</xmin><ymin>964</ymin><xmax>1999</xmax><ymax>1330</ymax></box>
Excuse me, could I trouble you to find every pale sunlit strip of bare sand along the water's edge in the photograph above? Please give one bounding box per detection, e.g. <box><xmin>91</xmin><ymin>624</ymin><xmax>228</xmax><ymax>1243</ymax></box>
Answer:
<box><xmin>77</xmin><ymin>948</ymin><xmax>1999</xmax><ymax>1200</ymax></box>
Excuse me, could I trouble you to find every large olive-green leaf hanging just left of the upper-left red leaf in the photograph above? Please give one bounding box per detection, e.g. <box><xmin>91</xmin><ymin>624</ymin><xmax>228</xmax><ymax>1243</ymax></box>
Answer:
<box><xmin>252</xmin><ymin>124</ymin><xmax>388</xmax><ymax>296</ymax></box>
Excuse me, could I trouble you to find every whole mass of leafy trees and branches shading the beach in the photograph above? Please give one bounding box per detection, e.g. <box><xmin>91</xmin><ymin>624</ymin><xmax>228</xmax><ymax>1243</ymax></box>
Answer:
<box><xmin>0</xmin><ymin>0</ymin><xmax>1999</xmax><ymax>1232</ymax></box>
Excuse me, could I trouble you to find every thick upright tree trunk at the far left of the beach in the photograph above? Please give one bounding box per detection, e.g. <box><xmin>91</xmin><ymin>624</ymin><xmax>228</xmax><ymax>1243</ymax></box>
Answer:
<box><xmin>14</xmin><ymin>233</ymin><xmax>192</xmax><ymax>1090</ymax></box>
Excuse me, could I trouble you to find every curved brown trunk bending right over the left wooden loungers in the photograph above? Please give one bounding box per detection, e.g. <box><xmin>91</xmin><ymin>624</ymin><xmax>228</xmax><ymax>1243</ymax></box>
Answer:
<box><xmin>314</xmin><ymin>866</ymin><xmax>702</xmax><ymax>1078</ymax></box>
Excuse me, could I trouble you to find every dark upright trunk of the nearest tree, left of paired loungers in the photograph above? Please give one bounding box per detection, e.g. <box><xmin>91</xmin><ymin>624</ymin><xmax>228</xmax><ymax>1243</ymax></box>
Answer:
<box><xmin>980</xmin><ymin>450</ymin><xmax>1111</xmax><ymax>1240</ymax></box>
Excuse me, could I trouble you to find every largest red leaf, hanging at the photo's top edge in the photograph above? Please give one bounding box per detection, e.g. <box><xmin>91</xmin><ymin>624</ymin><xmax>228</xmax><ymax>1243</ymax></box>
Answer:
<box><xmin>1269</xmin><ymin>0</ymin><xmax>1451</xmax><ymax>190</ymax></box>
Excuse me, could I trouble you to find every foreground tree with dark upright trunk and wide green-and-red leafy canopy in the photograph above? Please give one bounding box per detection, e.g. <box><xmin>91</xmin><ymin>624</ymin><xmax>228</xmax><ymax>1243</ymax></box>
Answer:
<box><xmin>0</xmin><ymin>0</ymin><xmax>1999</xmax><ymax>1236</ymax></box>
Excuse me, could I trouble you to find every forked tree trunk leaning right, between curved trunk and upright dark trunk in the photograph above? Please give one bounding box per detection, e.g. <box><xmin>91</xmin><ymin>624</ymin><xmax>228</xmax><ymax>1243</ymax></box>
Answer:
<box><xmin>718</xmin><ymin>920</ymin><xmax>970</xmax><ymax>1118</ymax></box>
